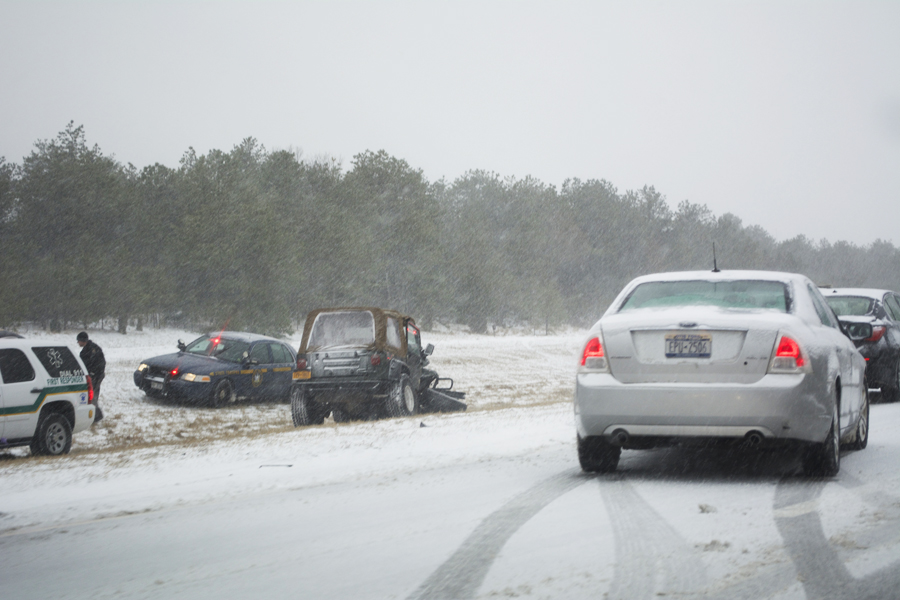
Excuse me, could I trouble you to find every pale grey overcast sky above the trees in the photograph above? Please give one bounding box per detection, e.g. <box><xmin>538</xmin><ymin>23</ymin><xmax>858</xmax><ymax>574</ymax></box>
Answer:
<box><xmin>0</xmin><ymin>0</ymin><xmax>900</xmax><ymax>245</ymax></box>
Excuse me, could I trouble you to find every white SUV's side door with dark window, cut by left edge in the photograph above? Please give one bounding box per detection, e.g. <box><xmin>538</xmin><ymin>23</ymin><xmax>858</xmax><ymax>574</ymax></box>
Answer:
<box><xmin>0</xmin><ymin>348</ymin><xmax>43</xmax><ymax>440</ymax></box>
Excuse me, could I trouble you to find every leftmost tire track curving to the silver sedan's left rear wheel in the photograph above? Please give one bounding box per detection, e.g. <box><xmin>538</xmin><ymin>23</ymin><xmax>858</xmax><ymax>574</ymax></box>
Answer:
<box><xmin>408</xmin><ymin>471</ymin><xmax>591</xmax><ymax>600</ymax></box>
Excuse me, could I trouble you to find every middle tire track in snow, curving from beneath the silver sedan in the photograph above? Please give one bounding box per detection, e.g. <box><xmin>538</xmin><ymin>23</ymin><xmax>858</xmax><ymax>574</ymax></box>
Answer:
<box><xmin>597</xmin><ymin>478</ymin><xmax>706</xmax><ymax>600</ymax></box>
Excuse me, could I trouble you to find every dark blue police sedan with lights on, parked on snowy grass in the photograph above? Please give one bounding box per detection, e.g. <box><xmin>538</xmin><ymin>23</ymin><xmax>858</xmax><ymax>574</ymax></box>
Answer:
<box><xmin>134</xmin><ymin>331</ymin><xmax>297</xmax><ymax>406</ymax></box>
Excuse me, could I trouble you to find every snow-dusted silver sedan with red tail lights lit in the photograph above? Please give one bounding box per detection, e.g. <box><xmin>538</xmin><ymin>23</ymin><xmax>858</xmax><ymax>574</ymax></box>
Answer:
<box><xmin>575</xmin><ymin>271</ymin><xmax>870</xmax><ymax>476</ymax></box>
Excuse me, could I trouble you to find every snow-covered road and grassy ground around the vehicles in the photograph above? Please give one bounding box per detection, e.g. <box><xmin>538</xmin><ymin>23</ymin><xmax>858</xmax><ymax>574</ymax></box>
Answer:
<box><xmin>0</xmin><ymin>331</ymin><xmax>900</xmax><ymax>599</ymax></box>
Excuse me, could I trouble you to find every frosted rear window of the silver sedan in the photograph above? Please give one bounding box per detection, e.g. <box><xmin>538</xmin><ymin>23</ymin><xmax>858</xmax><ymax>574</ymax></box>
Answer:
<box><xmin>619</xmin><ymin>280</ymin><xmax>790</xmax><ymax>313</ymax></box>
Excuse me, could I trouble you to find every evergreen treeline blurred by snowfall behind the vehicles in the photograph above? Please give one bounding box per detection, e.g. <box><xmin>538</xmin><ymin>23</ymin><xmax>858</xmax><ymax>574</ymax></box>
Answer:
<box><xmin>0</xmin><ymin>123</ymin><xmax>900</xmax><ymax>334</ymax></box>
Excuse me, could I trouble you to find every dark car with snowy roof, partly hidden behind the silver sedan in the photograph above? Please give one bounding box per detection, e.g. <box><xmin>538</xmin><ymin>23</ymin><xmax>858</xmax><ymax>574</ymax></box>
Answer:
<box><xmin>821</xmin><ymin>288</ymin><xmax>900</xmax><ymax>402</ymax></box>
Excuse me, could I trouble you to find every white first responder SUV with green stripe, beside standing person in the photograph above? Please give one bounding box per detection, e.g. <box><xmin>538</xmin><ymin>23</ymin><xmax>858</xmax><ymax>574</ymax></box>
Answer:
<box><xmin>0</xmin><ymin>338</ymin><xmax>95</xmax><ymax>455</ymax></box>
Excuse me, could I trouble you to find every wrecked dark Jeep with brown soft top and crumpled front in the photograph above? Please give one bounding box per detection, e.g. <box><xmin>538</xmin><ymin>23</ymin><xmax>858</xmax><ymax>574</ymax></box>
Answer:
<box><xmin>291</xmin><ymin>308</ymin><xmax>466</xmax><ymax>426</ymax></box>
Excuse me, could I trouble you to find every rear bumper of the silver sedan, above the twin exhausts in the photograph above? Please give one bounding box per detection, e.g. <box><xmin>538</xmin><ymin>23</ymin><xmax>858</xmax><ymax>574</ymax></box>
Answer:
<box><xmin>575</xmin><ymin>373</ymin><xmax>832</xmax><ymax>443</ymax></box>
